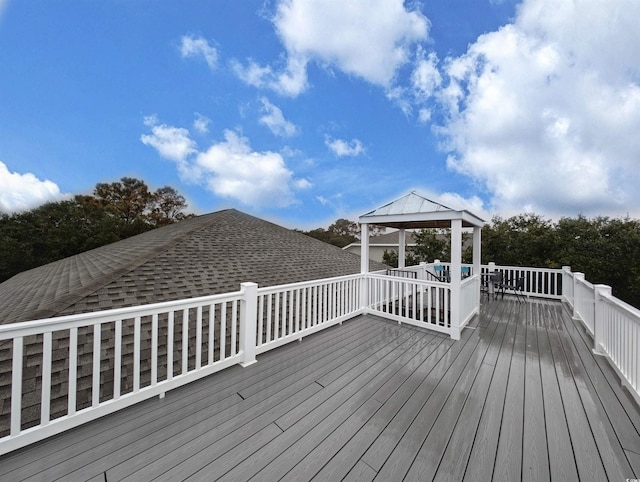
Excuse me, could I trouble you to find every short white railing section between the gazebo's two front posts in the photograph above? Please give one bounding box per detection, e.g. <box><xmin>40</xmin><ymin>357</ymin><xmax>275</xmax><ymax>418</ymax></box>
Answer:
<box><xmin>367</xmin><ymin>274</ymin><xmax>452</xmax><ymax>334</ymax></box>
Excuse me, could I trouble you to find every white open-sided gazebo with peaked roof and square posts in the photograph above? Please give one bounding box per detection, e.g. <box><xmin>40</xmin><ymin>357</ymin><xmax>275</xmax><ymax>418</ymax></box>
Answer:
<box><xmin>359</xmin><ymin>191</ymin><xmax>484</xmax><ymax>339</ymax></box>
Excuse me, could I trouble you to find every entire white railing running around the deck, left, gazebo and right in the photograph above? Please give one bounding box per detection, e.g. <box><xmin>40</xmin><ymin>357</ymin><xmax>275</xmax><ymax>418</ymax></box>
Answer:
<box><xmin>0</xmin><ymin>264</ymin><xmax>640</xmax><ymax>455</ymax></box>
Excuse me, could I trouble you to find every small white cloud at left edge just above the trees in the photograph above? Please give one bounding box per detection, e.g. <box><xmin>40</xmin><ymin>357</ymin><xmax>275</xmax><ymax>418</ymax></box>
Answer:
<box><xmin>0</xmin><ymin>162</ymin><xmax>68</xmax><ymax>213</ymax></box>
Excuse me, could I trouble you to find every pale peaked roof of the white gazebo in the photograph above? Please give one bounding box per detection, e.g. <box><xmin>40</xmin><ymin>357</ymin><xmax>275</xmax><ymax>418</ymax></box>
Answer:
<box><xmin>359</xmin><ymin>191</ymin><xmax>484</xmax><ymax>229</ymax></box>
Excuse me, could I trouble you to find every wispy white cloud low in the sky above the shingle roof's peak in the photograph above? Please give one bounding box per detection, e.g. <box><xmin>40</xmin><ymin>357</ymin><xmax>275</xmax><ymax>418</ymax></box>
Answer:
<box><xmin>140</xmin><ymin>117</ymin><xmax>311</xmax><ymax>207</ymax></box>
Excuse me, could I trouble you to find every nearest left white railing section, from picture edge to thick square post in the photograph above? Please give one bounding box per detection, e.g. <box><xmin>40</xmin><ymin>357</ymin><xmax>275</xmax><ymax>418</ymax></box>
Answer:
<box><xmin>0</xmin><ymin>291</ymin><xmax>249</xmax><ymax>454</ymax></box>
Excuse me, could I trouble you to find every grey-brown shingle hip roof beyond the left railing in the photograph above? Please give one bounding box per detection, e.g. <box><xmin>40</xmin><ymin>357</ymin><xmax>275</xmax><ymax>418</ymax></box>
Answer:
<box><xmin>0</xmin><ymin>209</ymin><xmax>384</xmax><ymax>324</ymax></box>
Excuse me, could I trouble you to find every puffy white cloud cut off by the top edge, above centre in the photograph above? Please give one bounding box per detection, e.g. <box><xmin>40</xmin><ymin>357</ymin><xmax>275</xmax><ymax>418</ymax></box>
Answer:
<box><xmin>232</xmin><ymin>0</ymin><xmax>429</xmax><ymax>96</ymax></box>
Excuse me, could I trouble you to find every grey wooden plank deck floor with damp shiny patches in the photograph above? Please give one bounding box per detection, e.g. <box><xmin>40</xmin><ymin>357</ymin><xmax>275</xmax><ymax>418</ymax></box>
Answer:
<box><xmin>0</xmin><ymin>298</ymin><xmax>640</xmax><ymax>481</ymax></box>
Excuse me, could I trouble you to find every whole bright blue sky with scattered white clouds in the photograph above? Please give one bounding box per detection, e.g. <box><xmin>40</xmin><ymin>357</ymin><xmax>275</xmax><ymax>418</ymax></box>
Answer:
<box><xmin>0</xmin><ymin>0</ymin><xmax>640</xmax><ymax>229</ymax></box>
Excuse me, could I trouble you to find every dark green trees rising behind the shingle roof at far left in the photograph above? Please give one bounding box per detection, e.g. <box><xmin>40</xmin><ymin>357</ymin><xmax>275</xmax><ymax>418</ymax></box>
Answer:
<box><xmin>0</xmin><ymin>178</ymin><xmax>187</xmax><ymax>282</ymax></box>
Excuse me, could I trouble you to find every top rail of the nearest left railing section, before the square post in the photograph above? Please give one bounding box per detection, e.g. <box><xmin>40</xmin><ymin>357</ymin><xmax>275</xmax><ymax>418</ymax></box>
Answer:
<box><xmin>0</xmin><ymin>291</ymin><xmax>242</xmax><ymax>340</ymax></box>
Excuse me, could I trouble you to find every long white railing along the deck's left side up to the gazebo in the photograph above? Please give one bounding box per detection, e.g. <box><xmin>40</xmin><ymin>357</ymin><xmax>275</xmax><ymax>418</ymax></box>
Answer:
<box><xmin>0</xmin><ymin>274</ymin><xmax>364</xmax><ymax>455</ymax></box>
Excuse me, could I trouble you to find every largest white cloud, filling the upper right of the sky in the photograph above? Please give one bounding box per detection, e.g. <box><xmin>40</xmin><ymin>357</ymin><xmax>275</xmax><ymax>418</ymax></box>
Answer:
<box><xmin>432</xmin><ymin>0</ymin><xmax>640</xmax><ymax>215</ymax></box>
